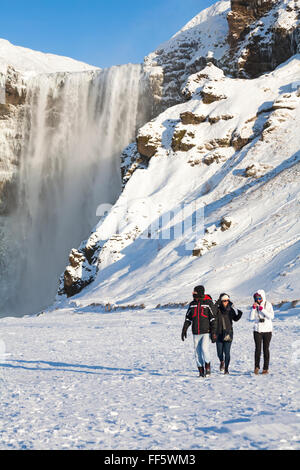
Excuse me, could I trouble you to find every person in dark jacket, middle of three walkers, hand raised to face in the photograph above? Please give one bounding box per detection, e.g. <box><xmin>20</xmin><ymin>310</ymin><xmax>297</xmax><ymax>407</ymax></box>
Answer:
<box><xmin>214</xmin><ymin>293</ymin><xmax>243</xmax><ymax>374</ymax></box>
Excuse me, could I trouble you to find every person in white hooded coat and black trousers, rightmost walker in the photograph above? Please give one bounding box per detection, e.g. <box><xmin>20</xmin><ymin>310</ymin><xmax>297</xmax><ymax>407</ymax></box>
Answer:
<box><xmin>250</xmin><ymin>289</ymin><xmax>274</xmax><ymax>375</ymax></box>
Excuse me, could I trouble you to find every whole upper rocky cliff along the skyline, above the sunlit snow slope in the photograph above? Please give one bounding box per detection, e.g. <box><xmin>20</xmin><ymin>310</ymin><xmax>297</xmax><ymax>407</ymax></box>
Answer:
<box><xmin>145</xmin><ymin>0</ymin><xmax>300</xmax><ymax>115</ymax></box>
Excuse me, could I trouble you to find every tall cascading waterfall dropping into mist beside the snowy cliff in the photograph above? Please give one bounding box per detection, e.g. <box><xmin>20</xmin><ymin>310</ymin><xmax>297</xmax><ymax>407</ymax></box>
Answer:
<box><xmin>2</xmin><ymin>65</ymin><xmax>148</xmax><ymax>315</ymax></box>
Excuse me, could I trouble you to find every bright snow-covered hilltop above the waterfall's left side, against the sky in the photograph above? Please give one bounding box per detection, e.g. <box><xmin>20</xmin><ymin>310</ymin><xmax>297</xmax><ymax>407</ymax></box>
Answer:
<box><xmin>0</xmin><ymin>39</ymin><xmax>98</xmax><ymax>73</ymax></box>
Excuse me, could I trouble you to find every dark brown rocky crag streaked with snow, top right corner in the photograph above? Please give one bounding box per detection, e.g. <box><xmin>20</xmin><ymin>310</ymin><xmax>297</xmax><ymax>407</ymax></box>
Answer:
<box><xmin>225</xmin><ymin>0</ymin><xmax>300</xmax><ymax>78</ymax></box>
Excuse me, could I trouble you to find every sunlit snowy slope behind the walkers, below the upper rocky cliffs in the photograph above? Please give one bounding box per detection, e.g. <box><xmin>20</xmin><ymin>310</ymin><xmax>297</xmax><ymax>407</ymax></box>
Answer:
<box><xmin>57</xmin><ymin>56</ymin><xmax>300</xmax><ymax>306</ymax></box>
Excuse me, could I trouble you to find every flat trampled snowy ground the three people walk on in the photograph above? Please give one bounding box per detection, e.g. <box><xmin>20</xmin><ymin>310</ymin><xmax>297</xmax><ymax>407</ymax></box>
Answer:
<box><xmin>0</xmin><ymin>307</ymin><xmax>300</xmax><ymax>450</ymax></box>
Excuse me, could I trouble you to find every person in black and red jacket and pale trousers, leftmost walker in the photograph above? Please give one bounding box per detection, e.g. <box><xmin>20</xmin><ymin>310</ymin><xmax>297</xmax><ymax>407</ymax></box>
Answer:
<box><xmin>181</xmin><ymin>286</ymin><xmax>215</xmax><ymax>377</ymax></box>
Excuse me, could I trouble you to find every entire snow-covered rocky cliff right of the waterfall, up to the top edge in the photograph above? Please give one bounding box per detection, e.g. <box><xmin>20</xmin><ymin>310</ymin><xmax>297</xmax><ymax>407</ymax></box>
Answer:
<box><xmin>58</xmin><ymin>1</ymin><xmax>300</xmax><ymax>306</ymax></box>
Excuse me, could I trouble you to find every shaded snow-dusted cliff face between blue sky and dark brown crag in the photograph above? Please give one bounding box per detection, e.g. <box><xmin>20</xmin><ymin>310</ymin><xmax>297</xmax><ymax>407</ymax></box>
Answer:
<box><xmin>144</xmin><ymin>1</ymin><xmax>229</xmax><ymax>115</ymax></box>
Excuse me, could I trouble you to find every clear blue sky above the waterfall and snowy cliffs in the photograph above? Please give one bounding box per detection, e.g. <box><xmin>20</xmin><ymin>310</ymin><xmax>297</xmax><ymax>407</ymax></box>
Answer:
<box><xmin>0</xmin><ymin>0</ymin><xmax>216</xmax><ymax>67</ymax></box>
